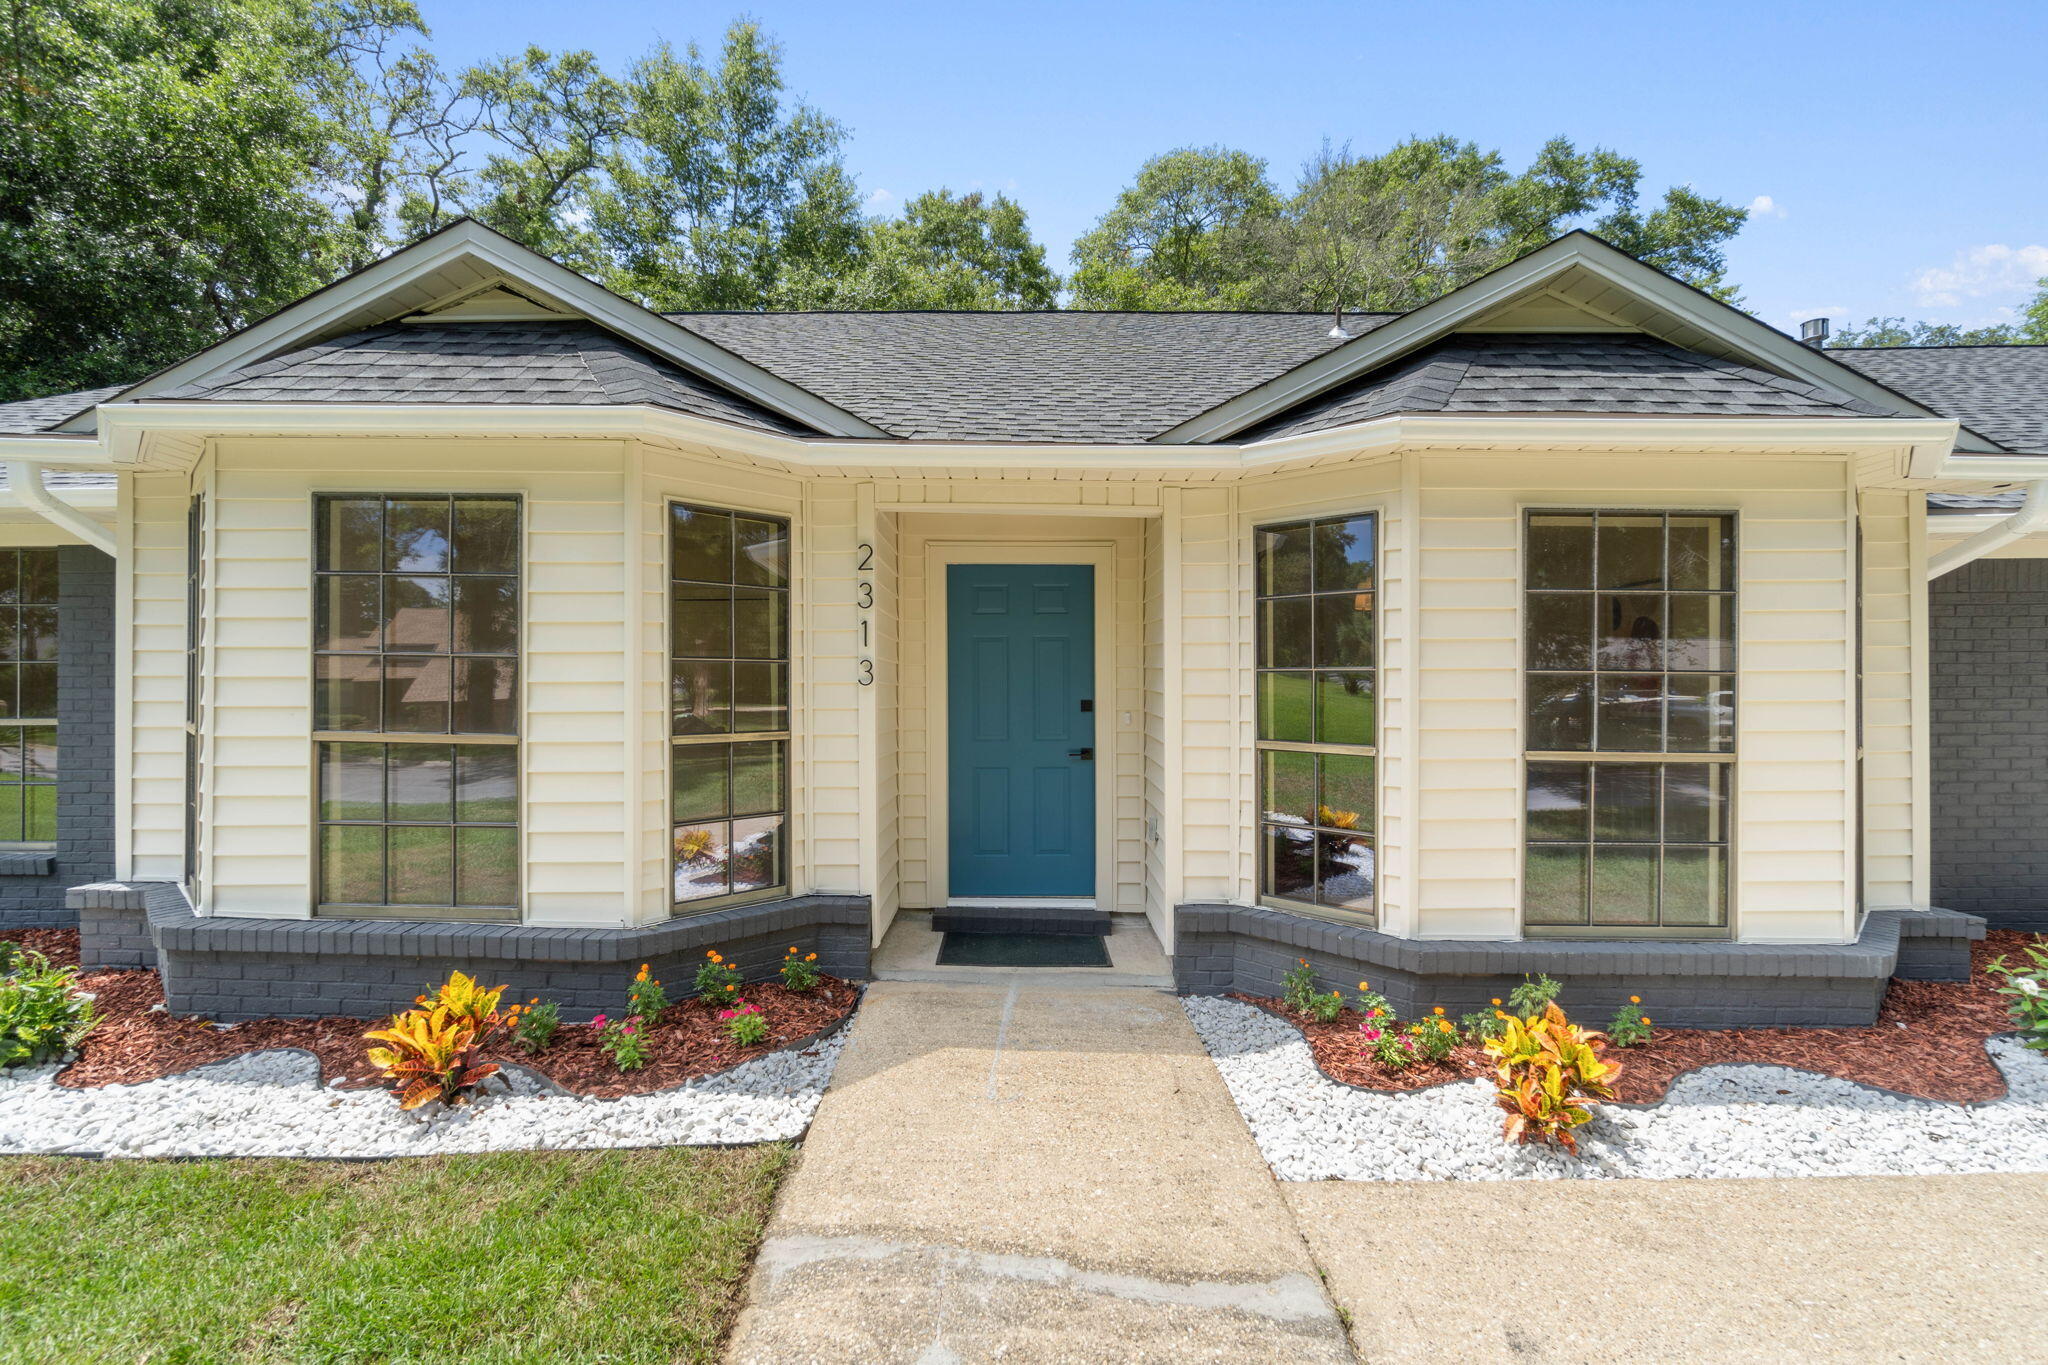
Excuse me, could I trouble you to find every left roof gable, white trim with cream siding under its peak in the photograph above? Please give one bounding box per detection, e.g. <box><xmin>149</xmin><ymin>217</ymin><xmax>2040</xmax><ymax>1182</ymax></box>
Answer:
<box><xmin>63</xmin><ymin>219</ymin><xmax>889</xmax><ymax>436</ymax></box>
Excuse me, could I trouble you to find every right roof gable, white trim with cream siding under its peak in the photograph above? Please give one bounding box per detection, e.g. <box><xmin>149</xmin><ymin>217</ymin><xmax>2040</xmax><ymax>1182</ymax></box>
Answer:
<box><xmin>1153</xmin><ymin>231</ymin><xmax>1999</xmax><ymax>450</ymax></box>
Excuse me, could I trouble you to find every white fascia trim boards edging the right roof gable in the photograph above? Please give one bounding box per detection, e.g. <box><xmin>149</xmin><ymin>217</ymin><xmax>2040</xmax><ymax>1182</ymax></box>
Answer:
<box><xmin>1153</xmin><ymin>233</ymin><xmax>1997</xmax><ymax>450</ymax></box>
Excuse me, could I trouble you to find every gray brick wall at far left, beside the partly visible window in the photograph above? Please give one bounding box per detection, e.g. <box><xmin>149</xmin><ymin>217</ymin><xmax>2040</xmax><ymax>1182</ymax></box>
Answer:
<box><xmin>0</xmin><ymin>544</ymin><xmax>115</xmax><ymax>929</ymax></box>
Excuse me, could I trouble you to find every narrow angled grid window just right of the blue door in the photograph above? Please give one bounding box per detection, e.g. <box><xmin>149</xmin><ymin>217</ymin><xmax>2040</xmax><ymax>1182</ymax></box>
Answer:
<box><xmin>1253</xmin><ymin>512</ymin><xmax>1378</xmax><ymax>923</ymax></box>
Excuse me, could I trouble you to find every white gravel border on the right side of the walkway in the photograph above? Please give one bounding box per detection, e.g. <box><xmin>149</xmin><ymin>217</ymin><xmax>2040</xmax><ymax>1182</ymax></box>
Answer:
<box><xmin>1182</xmin><ymin>997</ymin><xmax>2048</xmax><ymax>1181</ymax></box>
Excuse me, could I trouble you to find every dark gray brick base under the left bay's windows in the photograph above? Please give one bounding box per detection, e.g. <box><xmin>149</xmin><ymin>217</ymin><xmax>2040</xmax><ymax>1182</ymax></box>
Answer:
<box><xmin>72</xmin><ymin>882</ymin><xmax>868</xmax><ymax>1021</ymax></box>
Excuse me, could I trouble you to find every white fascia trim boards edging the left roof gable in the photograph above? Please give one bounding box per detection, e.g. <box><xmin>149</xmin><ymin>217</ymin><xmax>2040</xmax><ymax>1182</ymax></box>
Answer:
<box><xmin>61</xmin><ymin>221</ymin><xmax>887</xmax><ymax>436</ymax></box>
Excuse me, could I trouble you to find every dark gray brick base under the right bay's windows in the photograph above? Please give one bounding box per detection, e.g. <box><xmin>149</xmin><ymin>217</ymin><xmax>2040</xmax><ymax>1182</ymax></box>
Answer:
<box><xmin>1174</xmin><ymin>905</ymin><xmax>1985</xmax><ymax>1029</ymax></box>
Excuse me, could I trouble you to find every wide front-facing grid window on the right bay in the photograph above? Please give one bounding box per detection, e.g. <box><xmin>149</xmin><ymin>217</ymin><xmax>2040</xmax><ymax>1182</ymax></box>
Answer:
<box><xmin>1522</xmin><ymin>512</ymin><xmax>1737</xmax><ymax>937</ymax></box>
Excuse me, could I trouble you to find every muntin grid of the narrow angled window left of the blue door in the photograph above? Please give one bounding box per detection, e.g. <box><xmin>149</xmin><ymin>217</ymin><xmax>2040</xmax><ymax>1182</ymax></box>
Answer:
<box><xmin>666</xmin><ymin>501</ymin><xmax>795</xmax><ymax>915</ymax></box>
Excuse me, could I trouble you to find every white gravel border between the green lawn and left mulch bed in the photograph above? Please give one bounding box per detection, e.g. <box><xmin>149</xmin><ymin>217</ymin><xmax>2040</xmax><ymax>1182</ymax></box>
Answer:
<box><xmin>0</xmin><ymin>1025</ymin><xmax>848</xmax><ymax>1156</ymax></box>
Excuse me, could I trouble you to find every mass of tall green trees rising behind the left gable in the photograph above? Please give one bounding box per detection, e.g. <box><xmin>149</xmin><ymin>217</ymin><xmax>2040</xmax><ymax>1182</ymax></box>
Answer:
<box><xmin>0</xmin><ymin>10</ymin><xmax>1059</xmax><ymax>399</ymax></box>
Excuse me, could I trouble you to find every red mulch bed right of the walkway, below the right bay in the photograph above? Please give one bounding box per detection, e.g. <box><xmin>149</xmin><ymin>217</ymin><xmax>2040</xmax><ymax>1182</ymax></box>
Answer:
<box><xmin>1231</xmin><ymin>929</ymin><xmax>2048</xmax><ymax>1103</ymax></box>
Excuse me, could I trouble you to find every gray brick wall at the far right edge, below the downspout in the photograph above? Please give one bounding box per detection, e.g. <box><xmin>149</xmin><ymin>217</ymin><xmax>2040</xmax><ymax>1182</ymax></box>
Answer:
<box><xmin>1929</xmin><ymin>559</ymin><xmax>2048</xmax><ymax>931</ymax></box>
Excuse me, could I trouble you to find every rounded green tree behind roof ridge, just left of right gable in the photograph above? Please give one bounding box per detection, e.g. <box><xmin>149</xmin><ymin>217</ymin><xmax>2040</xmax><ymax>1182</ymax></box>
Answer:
<box><xmin>1071</xmin><ymin>147</ymin><xmax>1280</xmax><ymax>309</ymax></box>
